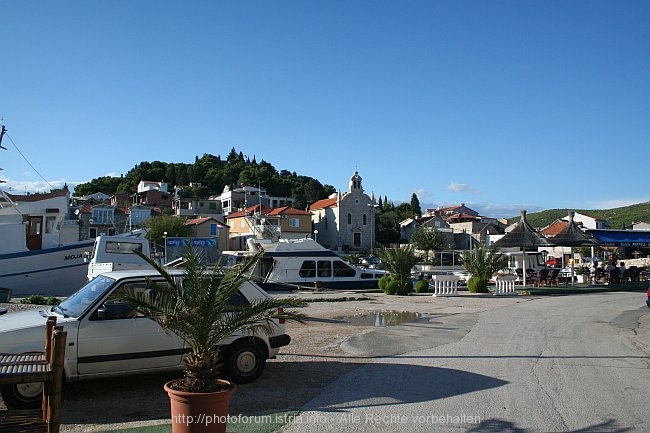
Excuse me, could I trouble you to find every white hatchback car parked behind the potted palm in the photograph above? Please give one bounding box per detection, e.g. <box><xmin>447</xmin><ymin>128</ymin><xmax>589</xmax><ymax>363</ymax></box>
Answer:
<box><xmin>0</xmin><ymin>270</ymin><xmax>291</xmax><ymax>409</ymax></box>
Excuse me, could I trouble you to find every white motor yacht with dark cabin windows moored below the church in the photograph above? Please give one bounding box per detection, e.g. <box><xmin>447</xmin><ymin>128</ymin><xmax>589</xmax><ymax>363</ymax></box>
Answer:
<box><xmin>222</xmin><ymin>217</ymin><xmax>387</xmax><ymax>291</ymax></box>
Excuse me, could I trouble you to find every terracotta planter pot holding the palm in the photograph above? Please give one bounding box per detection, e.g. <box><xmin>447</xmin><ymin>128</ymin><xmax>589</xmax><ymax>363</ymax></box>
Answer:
<box><xmin>165</xmin><ymin>380</ymin><xmax>236</xmax><ymax>433</ymax></box>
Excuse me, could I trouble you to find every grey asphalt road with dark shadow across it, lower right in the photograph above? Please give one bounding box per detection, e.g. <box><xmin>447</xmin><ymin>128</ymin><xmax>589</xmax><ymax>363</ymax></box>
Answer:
<box><xmin>281</xmin><ymin>293</ymin><xmax>650</xmax><ymax>433</ymax></box>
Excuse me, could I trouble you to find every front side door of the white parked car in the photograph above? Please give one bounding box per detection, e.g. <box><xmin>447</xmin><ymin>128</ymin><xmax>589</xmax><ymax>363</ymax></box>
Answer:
<box><xmin>77</xmin><ymin>279</ymin><xmax>185</xmax><ymax>375</ymax></box>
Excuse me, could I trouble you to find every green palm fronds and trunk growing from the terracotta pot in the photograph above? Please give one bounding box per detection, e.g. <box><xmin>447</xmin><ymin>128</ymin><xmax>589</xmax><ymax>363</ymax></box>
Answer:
<box><xmin>124</xmin><ymin>246</ymin><xmax>304</xmax><ymax>392</ymax></box>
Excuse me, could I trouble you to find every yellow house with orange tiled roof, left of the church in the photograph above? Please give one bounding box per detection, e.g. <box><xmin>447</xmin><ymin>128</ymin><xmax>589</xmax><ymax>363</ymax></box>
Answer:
<box><xmin>226</xmin><ymin>204</ymin><xmax>312</xmax><ymax>250</ymax></box>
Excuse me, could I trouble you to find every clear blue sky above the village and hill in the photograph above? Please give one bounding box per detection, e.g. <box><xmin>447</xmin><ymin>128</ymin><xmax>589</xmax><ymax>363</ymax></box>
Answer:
<box><xmin>0</xmin><ymin>0</ymin><xmax>650</xmax><ymax>217</ymax></box>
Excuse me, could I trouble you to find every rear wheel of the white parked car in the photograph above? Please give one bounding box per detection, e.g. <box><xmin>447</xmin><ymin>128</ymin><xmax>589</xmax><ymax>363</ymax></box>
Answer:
<box><xmin>223</xmin><ymin>341</ymin><xmax>266</xmax><ymax>383</ymax></box>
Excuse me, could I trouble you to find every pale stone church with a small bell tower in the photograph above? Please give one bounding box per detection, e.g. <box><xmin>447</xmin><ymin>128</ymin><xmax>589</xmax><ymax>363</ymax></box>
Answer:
<box><xmin>309</xmin><ymin>171</ymin><xmax>377</xmax><ymax>251</ymax></box>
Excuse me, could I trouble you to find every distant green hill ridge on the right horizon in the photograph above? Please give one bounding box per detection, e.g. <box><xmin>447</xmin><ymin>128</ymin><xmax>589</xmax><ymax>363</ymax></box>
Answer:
<box><xmin>508</xmin><ymin>202</ymin><xmax>650</xmax><ymax>229</ymax></box>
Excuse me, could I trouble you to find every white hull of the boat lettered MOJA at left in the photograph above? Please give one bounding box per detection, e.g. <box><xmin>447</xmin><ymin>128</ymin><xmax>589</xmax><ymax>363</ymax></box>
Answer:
<box><xmin>0</xmin><ymin>241</ymin><xmax>93</xmax><ymax>297</ymax></box>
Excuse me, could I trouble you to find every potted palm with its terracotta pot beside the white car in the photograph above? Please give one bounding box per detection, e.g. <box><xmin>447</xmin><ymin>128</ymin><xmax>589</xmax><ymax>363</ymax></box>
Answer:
<box><xmin>124</xmin><ymin>250</ymin><xmax>304</xmax><ymax>433</ymax></box>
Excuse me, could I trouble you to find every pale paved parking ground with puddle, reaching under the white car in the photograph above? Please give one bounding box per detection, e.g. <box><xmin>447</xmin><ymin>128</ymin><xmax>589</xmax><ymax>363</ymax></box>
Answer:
<box><xmin>1</xmin><ymin>292</ymin><xmax>531</xmax><ymax>432</ymax></box>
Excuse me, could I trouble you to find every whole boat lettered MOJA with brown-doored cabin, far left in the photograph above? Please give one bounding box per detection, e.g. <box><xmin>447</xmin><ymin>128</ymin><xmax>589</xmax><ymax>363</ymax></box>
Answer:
<box><xmin>0</xmin><ymin>189</ymin><xmax>93</xmax><ymax>297</ymax></box>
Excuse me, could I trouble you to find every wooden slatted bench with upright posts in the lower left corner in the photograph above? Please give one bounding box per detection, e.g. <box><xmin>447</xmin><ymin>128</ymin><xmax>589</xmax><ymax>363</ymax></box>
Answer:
<box><xmin>0</xmin><ymin>316</ymin><xmax>66</xmax><ymax>433</ymax></box>
